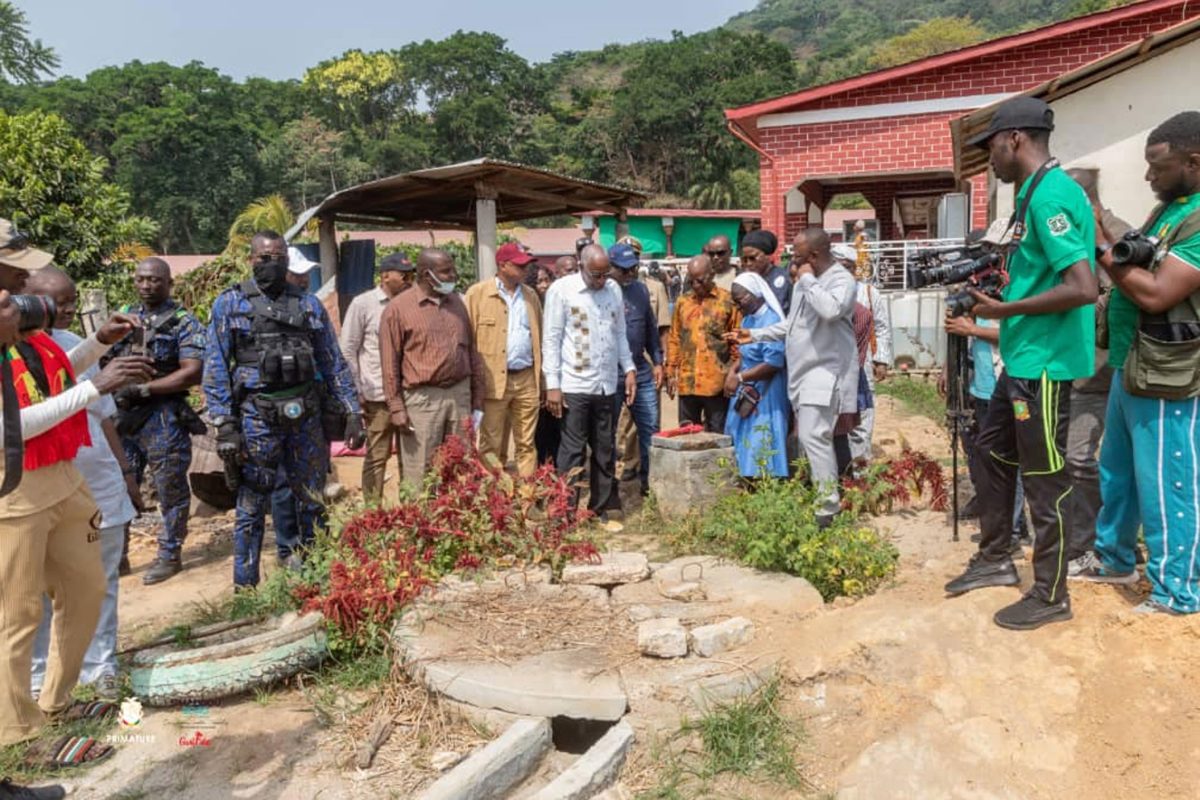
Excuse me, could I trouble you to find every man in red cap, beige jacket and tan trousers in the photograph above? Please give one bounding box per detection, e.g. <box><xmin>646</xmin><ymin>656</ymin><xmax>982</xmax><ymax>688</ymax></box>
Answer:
<box><xmin>467</xmin><ymin>242</ymin><xmax>541</xmax><ymax>475</ymax></box>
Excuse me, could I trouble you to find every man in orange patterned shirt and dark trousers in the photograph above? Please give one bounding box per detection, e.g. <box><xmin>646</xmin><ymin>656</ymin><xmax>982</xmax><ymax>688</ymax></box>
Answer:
<box><xmin>666</xmin><ymin>255</ymin><xmax>742</xmax><ymax>433</ymax></box>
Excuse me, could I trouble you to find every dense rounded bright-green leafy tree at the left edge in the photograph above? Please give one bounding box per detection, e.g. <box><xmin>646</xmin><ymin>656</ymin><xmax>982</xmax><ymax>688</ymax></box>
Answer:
<box><xmin>0</xmin><ymin>113</ymin><xmax>154</xmax><ymax>279</ymax></box>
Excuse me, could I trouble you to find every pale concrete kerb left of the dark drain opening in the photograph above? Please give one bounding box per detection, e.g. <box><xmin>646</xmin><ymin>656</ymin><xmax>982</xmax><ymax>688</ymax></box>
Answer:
<box><xmin>420</xmin><ymin>720</ymin><xmax>550</xmax><ymax>800</ymax></box>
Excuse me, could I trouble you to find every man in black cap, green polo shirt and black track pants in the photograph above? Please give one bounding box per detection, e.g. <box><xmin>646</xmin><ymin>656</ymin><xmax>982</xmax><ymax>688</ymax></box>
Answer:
<box><xmin>946</xmin><ymin>97</ymin><xmax>1097</xmax><ymax>630</ymax></box>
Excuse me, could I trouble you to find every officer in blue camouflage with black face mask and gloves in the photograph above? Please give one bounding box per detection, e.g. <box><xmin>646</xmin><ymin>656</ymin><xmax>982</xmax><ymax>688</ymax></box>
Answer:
<box><xmin>204</xmin><ymin>231</ymin><xmax>365</xmax><ymax>589</ymax></box>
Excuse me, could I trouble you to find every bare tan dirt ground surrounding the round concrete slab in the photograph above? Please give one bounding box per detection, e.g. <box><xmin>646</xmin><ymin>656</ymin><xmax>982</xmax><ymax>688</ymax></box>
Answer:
<box><xmin>49</xmin><ymin>397</ymin><xmax>1200</xmax><ymax>800</ymax></box>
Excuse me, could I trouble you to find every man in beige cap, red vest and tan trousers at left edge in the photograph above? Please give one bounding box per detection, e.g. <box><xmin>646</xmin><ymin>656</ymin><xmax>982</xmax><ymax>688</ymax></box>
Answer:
<box><xmin>0</xmin><ymin>219</ymin><xmax>152</xmax><ymax>772</ymax></box>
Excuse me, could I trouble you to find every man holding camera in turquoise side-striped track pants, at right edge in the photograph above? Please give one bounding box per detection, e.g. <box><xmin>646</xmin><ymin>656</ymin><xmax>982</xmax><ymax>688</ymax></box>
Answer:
<box><xmin>1080</xmin><ymin>112</ymin><xmax>1200</xmax><ymax>614</ymax></box>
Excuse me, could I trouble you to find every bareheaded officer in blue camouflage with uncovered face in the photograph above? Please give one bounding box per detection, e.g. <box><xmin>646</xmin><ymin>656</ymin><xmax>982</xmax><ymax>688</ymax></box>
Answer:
<box><xmin>106</xmin><ymin>258</ymin><xmax>204</xmax><ymax>584</ymax></box>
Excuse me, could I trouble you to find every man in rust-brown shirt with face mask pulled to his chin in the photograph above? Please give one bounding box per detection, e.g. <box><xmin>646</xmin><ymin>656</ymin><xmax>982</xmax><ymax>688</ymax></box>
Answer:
<box><xmin>379</xmin><ymin>248</ymin><xmax>486</xmax><ymax>487</ymax></box>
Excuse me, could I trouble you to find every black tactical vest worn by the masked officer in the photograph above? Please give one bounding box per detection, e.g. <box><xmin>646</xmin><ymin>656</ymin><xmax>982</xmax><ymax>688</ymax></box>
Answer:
<box><xmin>234</xmin><ymin>281</ymin><xmax>317</xmax><ymax>392</ymax></box>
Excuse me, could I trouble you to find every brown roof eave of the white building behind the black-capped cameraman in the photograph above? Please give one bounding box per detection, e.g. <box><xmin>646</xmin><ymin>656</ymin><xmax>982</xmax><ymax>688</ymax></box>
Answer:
<box><xmin>950</xmin><ymin>14</ymin><xmax>1200</xmax><ymax>179</ymax></box>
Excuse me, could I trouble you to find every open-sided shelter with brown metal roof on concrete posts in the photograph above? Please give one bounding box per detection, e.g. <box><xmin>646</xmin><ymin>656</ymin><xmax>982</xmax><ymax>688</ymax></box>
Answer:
<box><xmin>288</xmin><ymin>158</ymin><xmax>646</xmax><ymax>281</ymax></box>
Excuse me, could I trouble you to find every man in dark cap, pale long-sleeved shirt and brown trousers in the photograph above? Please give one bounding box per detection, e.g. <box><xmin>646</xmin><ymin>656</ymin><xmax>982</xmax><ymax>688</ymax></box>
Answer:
<box><xmin>337</xmin><ymin>253</ymin><xmax>415</xmax><ymax>505</ymax></box>
